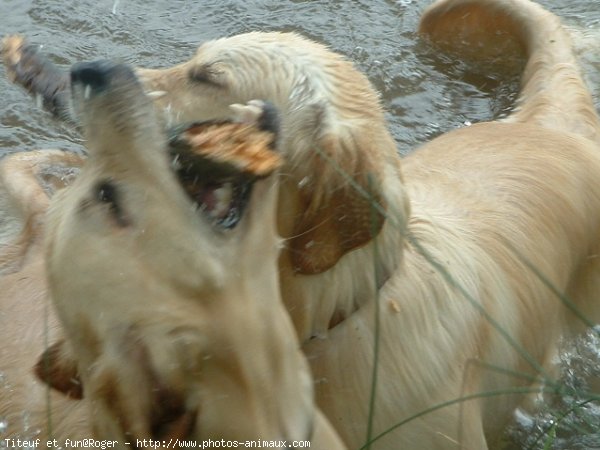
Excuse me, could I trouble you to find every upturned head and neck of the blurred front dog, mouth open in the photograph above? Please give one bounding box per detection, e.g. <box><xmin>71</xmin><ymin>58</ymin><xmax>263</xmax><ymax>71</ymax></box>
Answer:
<box><xmin>46</xmin><ymin>62</ymin><xmax>345</xmax><ymax>449</ymax></box>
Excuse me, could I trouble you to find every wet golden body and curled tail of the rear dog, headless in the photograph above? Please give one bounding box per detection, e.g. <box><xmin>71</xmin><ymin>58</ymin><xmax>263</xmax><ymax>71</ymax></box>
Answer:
<box><xmin>306</xmin><ymin>0</ymin><xmax>600</xmax><ymax>449</ymax></box>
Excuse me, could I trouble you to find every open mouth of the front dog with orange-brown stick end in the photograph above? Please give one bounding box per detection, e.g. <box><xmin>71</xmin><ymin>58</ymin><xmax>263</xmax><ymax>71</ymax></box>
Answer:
<box><xmin>169</xmin><ymin>122</ymin><xmax>281</xmax><ymax>229</ymax></box>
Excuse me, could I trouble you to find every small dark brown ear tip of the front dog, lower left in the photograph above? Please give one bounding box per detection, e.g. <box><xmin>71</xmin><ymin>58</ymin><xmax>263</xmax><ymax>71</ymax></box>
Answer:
<box><xmin>33</xmin><ymin>340</ymin><xmax>83</xmax><ymax>399</ymax></box>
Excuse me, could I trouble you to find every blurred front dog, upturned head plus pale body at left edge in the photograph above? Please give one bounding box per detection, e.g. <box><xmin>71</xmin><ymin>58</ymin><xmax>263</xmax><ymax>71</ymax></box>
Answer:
<box><xmin>0</xmin><ymin>64</ymin><xmax>345</xmax><ymax>449</ymax></box>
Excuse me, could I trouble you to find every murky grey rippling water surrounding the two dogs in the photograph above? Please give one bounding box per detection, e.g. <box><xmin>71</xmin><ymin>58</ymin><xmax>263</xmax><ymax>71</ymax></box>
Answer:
<box><xmin>0</xmin><ymin>0</ymin><xmax>600</xmax><ymax>450</ymax></box>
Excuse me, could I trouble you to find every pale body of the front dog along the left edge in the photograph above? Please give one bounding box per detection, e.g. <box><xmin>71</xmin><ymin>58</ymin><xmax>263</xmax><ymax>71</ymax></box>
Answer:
<box><xmin>0</xmin><ymin>150</ymin><xmax>91</xmax><ymax>442</ymax></box>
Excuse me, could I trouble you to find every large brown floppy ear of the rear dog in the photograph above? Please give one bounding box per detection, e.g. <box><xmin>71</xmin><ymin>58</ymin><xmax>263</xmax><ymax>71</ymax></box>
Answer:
<box><xmin>289</xmin><ymin>132</ymin><xmax>385</xmax><ymax>275</ymax></box>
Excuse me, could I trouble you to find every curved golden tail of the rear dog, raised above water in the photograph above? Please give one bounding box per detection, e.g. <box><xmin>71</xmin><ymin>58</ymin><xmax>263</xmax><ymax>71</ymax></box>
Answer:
<box><xmin>419</xmin><ymin>0</ymin><xmax>600</xmax><ymax>143</ymax></box>
